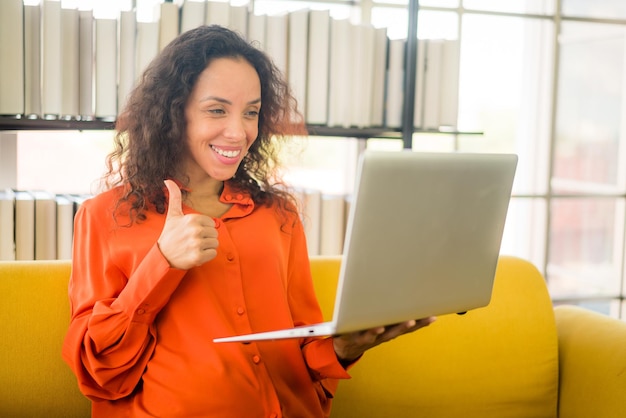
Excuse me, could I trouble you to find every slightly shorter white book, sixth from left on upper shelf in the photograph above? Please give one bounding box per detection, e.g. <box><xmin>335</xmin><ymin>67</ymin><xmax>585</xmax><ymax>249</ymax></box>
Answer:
<box><xmin>95</xmin><ymin>19</ymin><xmax>117</xmax><ymax>119</ymax></box>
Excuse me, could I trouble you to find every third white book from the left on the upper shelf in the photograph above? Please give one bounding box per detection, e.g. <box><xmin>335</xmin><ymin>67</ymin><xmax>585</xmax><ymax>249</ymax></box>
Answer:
<box><xmin>41</xmin><ymin>0</ymin><xmax>63</xmax><ymax>117</ymax></box>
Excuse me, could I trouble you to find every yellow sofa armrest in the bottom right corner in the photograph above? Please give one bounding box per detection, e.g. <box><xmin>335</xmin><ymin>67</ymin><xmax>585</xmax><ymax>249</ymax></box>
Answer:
<box><xmin>555</xmin><ymin>306</ymin><xmax>626</xmax><ymax>418</ymax></box>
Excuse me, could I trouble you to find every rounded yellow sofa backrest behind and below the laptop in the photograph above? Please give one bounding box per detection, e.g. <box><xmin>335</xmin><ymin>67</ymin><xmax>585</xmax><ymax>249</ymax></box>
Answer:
<box><xmin>312</xmin><ymin>257</ymin><xmax>558</xmax><ymax>418</ymax></box>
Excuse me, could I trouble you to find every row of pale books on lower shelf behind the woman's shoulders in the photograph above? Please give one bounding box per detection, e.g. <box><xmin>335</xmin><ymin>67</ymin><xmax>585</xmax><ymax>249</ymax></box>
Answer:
<box><xmin>0</xmin><ymin>189</ymin><xmax>349</xmax><ymax>260</ymax></box>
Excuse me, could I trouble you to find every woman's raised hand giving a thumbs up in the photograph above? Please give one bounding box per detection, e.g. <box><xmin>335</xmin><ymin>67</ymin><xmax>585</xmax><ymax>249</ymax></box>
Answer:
<box><xmin>157</xmin><ymin>180</ymin><xmax>218</xmax><ymax>270</ymax></box>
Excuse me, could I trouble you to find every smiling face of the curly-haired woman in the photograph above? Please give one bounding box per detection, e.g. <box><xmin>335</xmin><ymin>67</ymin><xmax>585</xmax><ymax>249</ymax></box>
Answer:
<box><xmin>183</xmin><ymin>58</ymin><xmax>261</xmax><ymax>184</ymax></box>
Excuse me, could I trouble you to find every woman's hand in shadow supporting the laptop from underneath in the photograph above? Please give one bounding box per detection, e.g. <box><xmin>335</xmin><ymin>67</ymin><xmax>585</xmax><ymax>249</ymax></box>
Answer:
<box><xmin>333</xmin><ymin>317</ymin><xmax>435</xmax><ymax>364</ymax></box>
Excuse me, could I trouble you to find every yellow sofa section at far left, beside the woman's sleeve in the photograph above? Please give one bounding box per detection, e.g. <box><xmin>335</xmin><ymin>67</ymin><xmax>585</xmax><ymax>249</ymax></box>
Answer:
<box><xmin>0</xmin><ymin>260</ymin><xmax>91</xmax><ymax>418</ymax></box>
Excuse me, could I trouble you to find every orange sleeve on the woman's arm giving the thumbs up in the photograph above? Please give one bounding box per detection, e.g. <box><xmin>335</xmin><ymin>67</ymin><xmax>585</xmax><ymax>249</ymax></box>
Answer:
<box><xmin>63</xmin><ymin>191</ymin><xmax>185</xmax><ymax>400</ymax></box>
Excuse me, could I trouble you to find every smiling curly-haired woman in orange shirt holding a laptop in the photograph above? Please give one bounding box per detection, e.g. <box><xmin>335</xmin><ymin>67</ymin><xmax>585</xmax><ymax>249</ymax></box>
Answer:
<box><xmin>63</xmin><ymin>26</ymin><xmax>431</xmax><ymax>418</ymax></box>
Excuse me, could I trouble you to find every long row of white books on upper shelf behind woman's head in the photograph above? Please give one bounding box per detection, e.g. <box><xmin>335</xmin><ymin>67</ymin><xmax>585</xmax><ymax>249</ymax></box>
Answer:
<box><xmin>0</xmin><ymin>0</ymin><xmax>459</xmax><ymax>129</ymax></box>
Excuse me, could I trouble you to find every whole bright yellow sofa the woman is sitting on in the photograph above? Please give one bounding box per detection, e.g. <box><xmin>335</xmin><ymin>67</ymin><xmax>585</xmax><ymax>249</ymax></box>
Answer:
<box><xmin>0</xmin><ymin>257</ymin><xmax>626</xmax><ymax>418</ymax></box>
